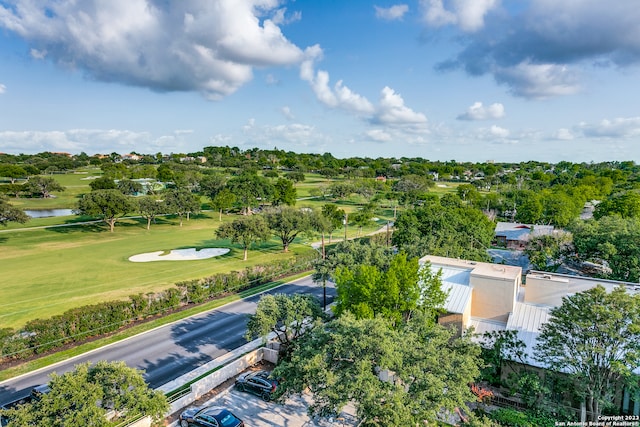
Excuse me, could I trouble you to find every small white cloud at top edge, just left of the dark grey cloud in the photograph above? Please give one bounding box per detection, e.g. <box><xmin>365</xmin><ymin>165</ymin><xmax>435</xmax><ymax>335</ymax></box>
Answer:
<box><xmin>420</xmin><ymin>0</ymin><xmax>498</xmax><ymax>32</ymax></box>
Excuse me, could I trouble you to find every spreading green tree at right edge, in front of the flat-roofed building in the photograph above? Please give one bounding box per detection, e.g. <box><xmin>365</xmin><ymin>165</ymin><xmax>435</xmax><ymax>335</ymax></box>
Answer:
<box><xmin>535</xmin><ymin>285</ymin><xmax>640</xmax><ymax>421</ymax></box>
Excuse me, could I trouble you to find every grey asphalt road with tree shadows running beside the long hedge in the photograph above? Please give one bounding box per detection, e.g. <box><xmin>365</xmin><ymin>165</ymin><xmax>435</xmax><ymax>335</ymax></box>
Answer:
<box><xmin>0</xmin><ymin>277</ymin><xmax>335</xmax><ymax>405</ymax></box>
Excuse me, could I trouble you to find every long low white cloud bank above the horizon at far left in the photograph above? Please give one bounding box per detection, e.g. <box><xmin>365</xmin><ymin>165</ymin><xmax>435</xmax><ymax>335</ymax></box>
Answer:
<box><xmin>0</xmin><ymin>129</ymin><xmax>192</xmax><ymax>154</ymax></box>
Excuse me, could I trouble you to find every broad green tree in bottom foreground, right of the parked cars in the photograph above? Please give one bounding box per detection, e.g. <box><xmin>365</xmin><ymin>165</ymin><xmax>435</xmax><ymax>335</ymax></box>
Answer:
<box><xmin>274</xmin><ymin>313</ymin><xmax>480</xmax><ymax>426</ymax></box>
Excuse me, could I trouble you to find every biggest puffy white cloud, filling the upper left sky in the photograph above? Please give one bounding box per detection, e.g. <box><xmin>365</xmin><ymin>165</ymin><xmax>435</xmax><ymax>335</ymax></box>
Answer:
<box><xmin>0</xmin><ymin>0</ymin><xmax>304</xmax><ymax>99</ymax></box>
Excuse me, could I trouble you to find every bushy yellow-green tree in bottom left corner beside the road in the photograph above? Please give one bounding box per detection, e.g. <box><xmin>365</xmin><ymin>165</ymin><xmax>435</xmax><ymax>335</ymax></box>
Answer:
<box><xmin>3</xmin><ymin>361</ymin><xmax>169</xmax><ymax>427</ymax></box>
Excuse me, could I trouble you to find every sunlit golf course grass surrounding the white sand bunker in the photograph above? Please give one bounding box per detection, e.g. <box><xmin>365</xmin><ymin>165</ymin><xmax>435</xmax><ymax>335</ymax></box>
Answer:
<box><xmin>0</xmin><ymin>212</ymin><xmax>312</xmax><ymax>327</ymax></box>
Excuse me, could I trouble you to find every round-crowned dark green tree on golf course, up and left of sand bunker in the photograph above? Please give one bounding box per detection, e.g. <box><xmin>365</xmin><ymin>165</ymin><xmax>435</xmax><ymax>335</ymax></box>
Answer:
<box><xmin>78</xmin><ymin>190</ymin><xmax>134</xmax><ymax>233</ymax></box>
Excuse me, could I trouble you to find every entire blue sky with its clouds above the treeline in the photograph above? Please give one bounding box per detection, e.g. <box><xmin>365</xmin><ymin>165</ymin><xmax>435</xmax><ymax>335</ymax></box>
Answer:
<box><xmin>0</xmin><ymin>0</ymin><xmax>640</xmax><ymax>162</ymax></box>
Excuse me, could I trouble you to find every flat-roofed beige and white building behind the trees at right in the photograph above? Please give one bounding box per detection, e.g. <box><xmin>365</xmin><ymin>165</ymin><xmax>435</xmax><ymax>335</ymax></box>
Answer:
<box><xmin>420</xmin><ymin>255</ymin><xmax>640</xmax><ymax>368</ymax></box>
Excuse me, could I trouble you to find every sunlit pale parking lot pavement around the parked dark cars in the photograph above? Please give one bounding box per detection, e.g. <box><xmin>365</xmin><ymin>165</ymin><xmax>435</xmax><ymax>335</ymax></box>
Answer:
<box><xmin>172</xmin><ymin>387</ymin><xmax>358</xmax><ymax>427</ymax></box>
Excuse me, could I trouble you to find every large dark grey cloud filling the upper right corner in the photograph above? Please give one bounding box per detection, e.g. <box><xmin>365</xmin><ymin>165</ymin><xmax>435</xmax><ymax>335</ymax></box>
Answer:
<box><xmin>428</xmin><ymin>0</ymin><xmax>640</xmax><ymax>99</ymax></box>
